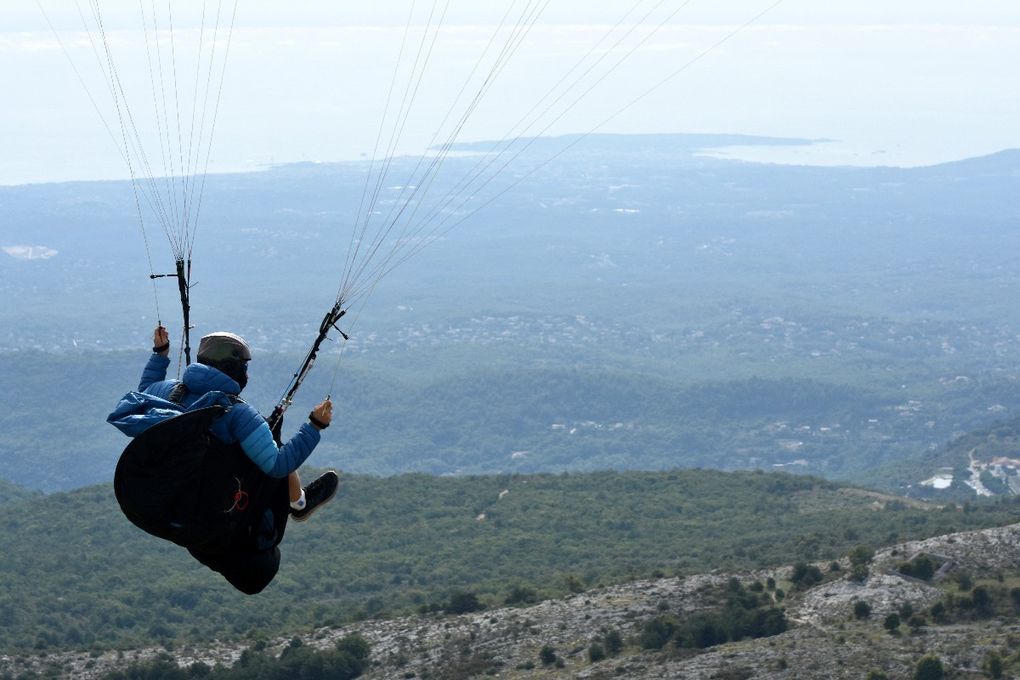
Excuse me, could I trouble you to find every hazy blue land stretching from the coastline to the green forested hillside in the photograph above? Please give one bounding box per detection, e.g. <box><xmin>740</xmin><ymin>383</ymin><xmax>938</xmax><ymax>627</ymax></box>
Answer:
<box><xmin>0</xmin><ymin>135</ymin><xmax>1020</xmax><ymax>491</ymax></box>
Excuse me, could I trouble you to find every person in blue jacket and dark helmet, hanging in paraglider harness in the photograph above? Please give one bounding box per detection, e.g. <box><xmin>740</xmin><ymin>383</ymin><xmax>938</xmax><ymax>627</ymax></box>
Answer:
<box><xmin>107</xmin><ymin>326</ymin><xmax>339</xmax><ymax>594</ymax></box>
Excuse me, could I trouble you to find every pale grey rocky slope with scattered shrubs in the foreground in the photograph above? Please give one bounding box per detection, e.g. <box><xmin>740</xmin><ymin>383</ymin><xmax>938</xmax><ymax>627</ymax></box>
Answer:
<box><xmin>0</xmin><ymin>524</ymin><xmax>1020</xmax><ymax>680</ymax></box>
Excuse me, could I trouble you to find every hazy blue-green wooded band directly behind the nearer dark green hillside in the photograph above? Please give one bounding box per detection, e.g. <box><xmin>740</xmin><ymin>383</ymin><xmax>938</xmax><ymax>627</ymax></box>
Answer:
<box><xmin>0</xmin><ymin>349</ymin><xmax>1020</xmax><ymax>493</ymax></box>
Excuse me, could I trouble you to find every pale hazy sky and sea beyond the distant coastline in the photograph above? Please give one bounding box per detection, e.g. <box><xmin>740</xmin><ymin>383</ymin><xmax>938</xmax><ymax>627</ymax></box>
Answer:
<box><xmin>0</xmin><ymin>0</ymin><xmax>1020</xmax><ymax>185</ymax></box>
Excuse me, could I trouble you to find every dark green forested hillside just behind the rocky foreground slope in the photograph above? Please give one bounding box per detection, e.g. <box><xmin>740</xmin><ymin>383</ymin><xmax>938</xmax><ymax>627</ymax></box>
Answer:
<box><xmin>0</xmin><ymin>470</ymin><xmax>1020</xmax><ymax>653</ymax></box>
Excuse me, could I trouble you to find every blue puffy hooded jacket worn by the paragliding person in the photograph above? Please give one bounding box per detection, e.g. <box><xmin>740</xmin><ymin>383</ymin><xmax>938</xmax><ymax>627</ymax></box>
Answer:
<box><xmin>106</xmin><ymin>354</ymin><xmax>320</xmax><ymax>478</ymax></box>
